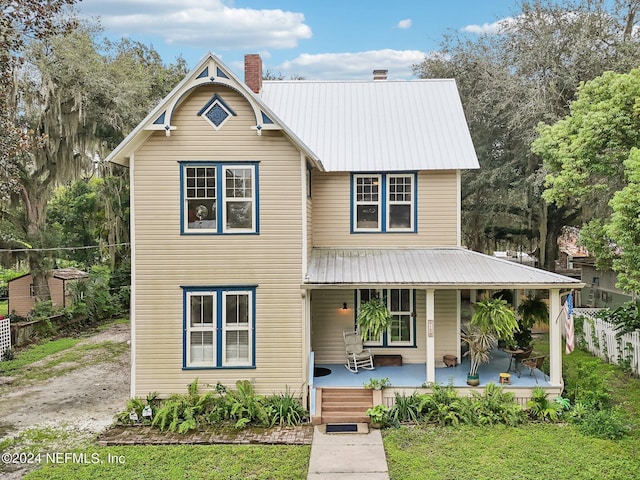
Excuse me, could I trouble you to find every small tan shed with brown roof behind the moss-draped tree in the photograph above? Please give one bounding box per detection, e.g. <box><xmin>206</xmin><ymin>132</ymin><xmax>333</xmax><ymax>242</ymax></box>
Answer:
<box><xmin>7</xmin><ymin>268</ymin><xmax>89</xmax><ymax>317</ymax></box>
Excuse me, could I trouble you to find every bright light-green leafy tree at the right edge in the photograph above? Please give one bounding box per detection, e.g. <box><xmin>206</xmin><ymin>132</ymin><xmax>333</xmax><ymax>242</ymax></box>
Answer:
<box><xmin>533</xmin><ymin>69</ymin><xmax>640</xmax><ymax>291</ymax></box>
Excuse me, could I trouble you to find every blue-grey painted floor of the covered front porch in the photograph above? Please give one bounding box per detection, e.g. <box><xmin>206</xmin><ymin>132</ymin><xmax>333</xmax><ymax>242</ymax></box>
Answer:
<box><xmin>313</xmin><ymin>350</ymin><xmax>550</xmax><ymax>388</ymax></box>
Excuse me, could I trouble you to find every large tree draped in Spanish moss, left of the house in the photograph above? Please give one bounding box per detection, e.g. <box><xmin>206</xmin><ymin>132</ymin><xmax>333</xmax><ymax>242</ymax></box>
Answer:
<box><xmin>2</xmin><ymin>25</ymin><xmax>186</xmax><ymax>300</ymax></box>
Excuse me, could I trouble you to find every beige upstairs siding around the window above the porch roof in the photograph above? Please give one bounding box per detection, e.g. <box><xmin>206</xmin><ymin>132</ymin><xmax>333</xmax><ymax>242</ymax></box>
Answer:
<box><xmin>313</xmin><ymin>170</ymin><xmax>458</xmax><ymax>247</ymax></box>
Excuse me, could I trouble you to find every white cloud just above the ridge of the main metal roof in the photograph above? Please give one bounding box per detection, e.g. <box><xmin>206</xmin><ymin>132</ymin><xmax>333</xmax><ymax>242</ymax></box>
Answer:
<box><xmin>278</xmin><ymin>49</ymin><xmax>425</xmax><ymax>80</ymax></box>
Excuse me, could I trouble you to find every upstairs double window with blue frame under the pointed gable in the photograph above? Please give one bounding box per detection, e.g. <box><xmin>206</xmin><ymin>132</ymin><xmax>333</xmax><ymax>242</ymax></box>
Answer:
<box><xmin>182</xmin><ymin>163</ymin><xmax>258</xmax><ymax>233</ymax></box>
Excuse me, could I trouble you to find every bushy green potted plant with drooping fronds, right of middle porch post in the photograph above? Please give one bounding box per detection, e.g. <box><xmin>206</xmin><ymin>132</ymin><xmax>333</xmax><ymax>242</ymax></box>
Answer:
<box><xmin>461</xmin><ymin>298</ymin><xmax>518</xmax><ymax>386</ymax></box>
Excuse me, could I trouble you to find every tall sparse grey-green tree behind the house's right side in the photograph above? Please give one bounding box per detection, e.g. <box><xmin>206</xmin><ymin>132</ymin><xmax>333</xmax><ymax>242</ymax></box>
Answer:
<box><xmin>414</xmin><ymin>0</ymin><xmax>640</xmax><ymax>270</ymax></box>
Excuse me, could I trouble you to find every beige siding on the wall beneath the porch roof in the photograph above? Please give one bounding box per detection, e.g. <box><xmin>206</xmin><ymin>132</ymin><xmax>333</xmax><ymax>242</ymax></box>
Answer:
<box><xmin>311</xmin><ymin>290</ymin><xmax>459</xmax><ymax>363</ymax></box>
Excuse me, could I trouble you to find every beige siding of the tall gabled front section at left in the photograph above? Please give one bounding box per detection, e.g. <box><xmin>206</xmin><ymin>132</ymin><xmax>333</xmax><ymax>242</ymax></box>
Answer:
<box><xmin>133</xmin><ymin>86</ymin><xmax>304</xmax><ymax>395</ymax></box>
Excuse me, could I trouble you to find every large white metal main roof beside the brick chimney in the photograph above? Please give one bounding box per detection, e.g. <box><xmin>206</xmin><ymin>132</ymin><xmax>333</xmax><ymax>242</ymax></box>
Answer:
<box><xmin>261</xmin><ymin>79</ymin><xmax>479</xmax><ymax>172</ymax></box>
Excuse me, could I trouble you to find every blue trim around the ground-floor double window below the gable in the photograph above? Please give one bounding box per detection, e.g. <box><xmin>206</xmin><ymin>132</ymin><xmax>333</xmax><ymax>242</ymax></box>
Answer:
<box><xmin>180</xmin><ymin>285</ymin><xmax>258</xmax><ymax>370</ymax></box>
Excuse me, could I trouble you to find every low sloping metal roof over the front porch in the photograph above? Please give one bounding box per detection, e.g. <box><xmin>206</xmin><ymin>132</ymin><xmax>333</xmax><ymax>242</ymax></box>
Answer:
<box><xmin>304</xmin><ymin>247</ymin><xmax>584</xmax><ymax>289</ymax></box>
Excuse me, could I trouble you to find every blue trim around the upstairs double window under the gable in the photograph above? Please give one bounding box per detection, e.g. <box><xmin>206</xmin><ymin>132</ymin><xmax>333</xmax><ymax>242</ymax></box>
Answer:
<box><xmin>178</xmin><ymin>160</ymin><xmax>260</xmax><ymax>235</ymax></box>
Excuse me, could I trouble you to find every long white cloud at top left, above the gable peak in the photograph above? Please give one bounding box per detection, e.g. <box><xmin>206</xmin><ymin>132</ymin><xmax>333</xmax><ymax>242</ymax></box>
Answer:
<box><xmin>80</xmin><ymin>0</ymin><xmax>312</xmax><ymax>50</ymax></box>
